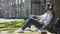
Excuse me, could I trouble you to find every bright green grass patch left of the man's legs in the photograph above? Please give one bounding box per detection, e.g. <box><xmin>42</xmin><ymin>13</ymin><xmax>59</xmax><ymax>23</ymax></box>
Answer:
<box><xmin>0</xmin><ymin>20</ymin><xmax>25</xmax><ymax>31</ymax></box>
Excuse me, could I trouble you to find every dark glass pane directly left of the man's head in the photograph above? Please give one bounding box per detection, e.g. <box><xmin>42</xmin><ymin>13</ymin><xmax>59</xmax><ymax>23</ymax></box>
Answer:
<box><xmin>32</xmin><ymin>0</ymin><xmax>44</xmax><ymax>15</ymax></box>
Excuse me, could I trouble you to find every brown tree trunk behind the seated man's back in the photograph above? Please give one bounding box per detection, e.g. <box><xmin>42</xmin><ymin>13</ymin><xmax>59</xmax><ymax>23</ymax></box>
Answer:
<box><xmin>47</xmin><ymin>0</ymin><xmax>60</xmax><ymax>32</ymax></box>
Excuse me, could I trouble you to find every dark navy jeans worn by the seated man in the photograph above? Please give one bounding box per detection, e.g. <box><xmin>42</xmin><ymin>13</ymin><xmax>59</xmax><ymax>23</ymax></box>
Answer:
<box><xmin>22</xmin><ymin>18</ymin><xmax>43</xmax><ymax>30</ymax></box>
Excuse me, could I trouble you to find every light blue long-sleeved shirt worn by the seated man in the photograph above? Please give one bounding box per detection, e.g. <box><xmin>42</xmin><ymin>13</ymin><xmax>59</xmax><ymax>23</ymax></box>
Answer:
<box><xmin>38</xmin><ymin>10</ymin><xmax>53</xmax><ymax>25</ymax></box>
